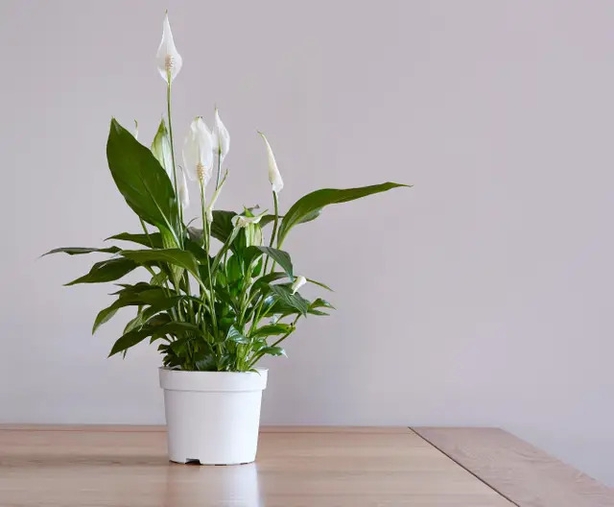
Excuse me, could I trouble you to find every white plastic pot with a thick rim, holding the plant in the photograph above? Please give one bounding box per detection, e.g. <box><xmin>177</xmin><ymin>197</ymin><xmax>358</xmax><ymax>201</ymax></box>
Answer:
<box><xmin>160</xmin><ymin>368</ymin><xmax>268</xmax><ymax>465</ymax></box>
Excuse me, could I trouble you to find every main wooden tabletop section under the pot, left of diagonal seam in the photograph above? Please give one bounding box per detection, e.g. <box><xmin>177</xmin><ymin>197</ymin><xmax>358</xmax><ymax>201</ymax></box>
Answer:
<box><xmin>0</xmin><ymin>427</ymin><xmax>512</xmax><ymax>507</ymax></box>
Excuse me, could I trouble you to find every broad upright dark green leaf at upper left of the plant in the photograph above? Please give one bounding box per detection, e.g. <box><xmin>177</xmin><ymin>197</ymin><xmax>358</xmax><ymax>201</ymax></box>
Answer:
<box><xmin>107</xmin><ymin>119</ymin><xmax>179</xmax><ymax>244</ymax></box>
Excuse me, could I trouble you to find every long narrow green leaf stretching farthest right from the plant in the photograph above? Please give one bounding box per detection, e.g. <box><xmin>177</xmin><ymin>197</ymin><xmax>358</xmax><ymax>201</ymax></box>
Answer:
<box><xmin>277</xmin><ymin>182</ymin><xmax>411</xmax><ymax>246</ymax></box>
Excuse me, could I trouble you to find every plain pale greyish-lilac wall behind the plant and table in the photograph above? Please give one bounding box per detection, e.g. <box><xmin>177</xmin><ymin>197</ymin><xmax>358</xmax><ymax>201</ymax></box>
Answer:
<box><xmin>0</xmin><ymin>0</ymin><xmax>614</xmax><ymax>485</ymax></box>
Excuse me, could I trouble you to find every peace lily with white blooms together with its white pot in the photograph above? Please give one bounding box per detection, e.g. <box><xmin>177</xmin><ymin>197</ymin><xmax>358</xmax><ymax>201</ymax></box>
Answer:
<box><xmin>43</xmin><ymin>12</ymin><xmax>405</xmax><ymax>464</ymax></box>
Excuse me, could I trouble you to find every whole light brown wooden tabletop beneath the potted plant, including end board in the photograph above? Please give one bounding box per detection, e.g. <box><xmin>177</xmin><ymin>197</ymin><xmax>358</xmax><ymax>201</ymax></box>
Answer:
<box><xmin>0</xmin><ymin>426</ymin><xmax>614</xmax><ymax>507</ymax></box>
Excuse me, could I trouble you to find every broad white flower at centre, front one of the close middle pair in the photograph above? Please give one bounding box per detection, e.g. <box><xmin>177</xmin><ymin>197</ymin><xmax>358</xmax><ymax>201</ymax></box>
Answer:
<box><xmin>183</xmin><ymin>116</ymin><xmax>213</xmax><ymax>186</ymax></box>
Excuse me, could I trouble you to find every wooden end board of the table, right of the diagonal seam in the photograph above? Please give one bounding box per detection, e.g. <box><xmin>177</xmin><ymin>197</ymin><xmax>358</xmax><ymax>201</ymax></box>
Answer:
<box><xmin>413</xmin><ymin>428</ymin><xmax>614</xmax><ymax>507</ymax></box>
